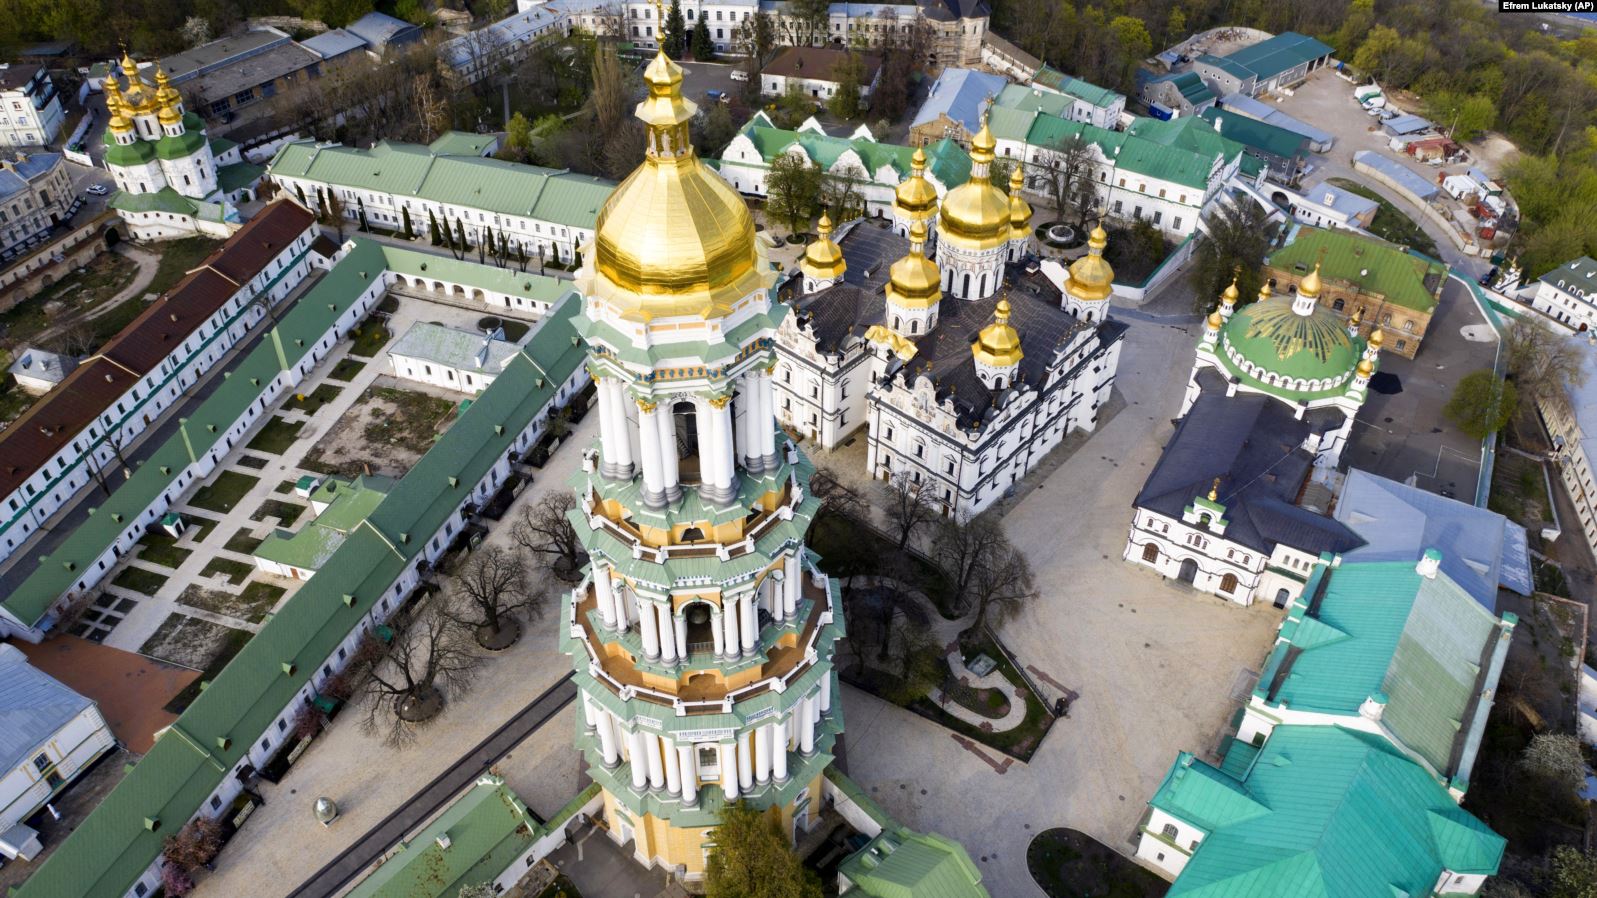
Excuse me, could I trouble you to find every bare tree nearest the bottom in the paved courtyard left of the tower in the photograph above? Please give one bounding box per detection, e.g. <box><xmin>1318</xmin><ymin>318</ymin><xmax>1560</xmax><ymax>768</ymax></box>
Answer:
<box><xmin>363</xmin><ymin>607</ymin><xmax>481</xmax><ymax>745</ymax></box>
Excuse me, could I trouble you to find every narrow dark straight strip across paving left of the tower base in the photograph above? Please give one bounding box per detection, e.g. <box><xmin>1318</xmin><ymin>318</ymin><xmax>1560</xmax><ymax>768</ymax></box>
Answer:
<box><xmin>289</xmin><ymin>673</ymin><xmax>577</xmax><ymax>898</ymax></box>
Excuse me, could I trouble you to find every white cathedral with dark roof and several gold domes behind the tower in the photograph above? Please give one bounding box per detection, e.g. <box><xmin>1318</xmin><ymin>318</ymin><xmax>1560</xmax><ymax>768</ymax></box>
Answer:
<box><xmin>775</xmin><ymin>109</ymin><xmax>1124</xmax><ymax>515</ymax></box>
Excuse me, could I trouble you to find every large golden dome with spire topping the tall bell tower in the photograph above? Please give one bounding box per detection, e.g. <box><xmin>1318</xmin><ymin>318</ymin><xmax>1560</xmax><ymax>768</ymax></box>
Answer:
<box><xmin>583</xmin><ymin>53</ymin><xmax>775</xmax><ymax>321</ymax></box>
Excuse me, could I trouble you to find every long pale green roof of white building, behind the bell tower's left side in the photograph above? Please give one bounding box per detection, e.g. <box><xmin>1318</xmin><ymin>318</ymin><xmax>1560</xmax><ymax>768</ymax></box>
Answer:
<box><xmin>268</xmin><ymin>141</ymin><xmax>615</xmax><ymax>228</ymax></box>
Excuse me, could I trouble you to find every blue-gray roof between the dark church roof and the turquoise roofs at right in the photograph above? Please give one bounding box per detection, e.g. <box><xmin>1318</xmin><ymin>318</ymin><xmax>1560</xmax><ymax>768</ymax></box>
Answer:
<box><xmin>1335</xmin><ymin>468</ymin><xmax>1533</xmax><ymax>610</ymax></box>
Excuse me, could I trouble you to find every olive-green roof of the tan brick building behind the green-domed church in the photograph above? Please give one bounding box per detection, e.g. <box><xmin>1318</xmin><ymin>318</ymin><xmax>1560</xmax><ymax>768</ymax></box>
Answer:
<box><xmin>1271</xmin><ymin>226</ymin><xmax>1447</xmax><ymax>313</ymax></box>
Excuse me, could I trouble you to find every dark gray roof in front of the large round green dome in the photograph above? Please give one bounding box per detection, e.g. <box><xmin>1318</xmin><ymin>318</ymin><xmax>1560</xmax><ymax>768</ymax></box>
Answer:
<box><xmin>1135</xmin><ymin>386</ymin><xmax>1362</xmax><ymax>554</ymax></box>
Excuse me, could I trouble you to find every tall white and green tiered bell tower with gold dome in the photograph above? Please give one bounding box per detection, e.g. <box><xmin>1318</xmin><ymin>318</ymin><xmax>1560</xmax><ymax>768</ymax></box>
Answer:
<box><xmin>561</xmin><ymin>43</ymin><xmax>983</xmax><ymax>898</ymax></box>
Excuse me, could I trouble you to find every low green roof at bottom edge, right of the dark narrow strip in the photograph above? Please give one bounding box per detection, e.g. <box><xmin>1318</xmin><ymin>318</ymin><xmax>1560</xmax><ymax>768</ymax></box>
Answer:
<box><xmin>348</xmin><ymin>775</ymin><xmax>543</xmax><ymax>898</ymax></box>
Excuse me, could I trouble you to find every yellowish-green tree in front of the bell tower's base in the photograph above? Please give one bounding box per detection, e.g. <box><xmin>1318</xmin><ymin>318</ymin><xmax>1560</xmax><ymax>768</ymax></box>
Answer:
<box><xmin>704</xmin><ymin>801</ymin><xmax>822</xmax><ymax>898</ymax></box>
